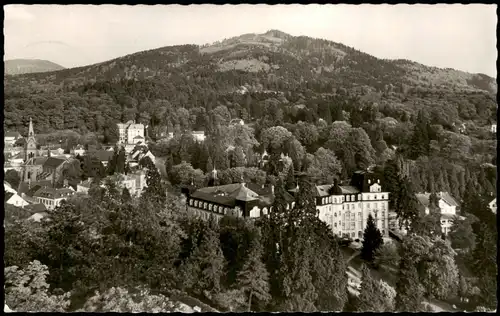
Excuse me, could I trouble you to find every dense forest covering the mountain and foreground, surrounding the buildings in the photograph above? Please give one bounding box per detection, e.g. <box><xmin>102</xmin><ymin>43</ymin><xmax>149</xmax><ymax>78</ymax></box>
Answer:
<box><xmin>4</xmin><ymin>31</ymin><xmax>497</xmax><ymax>311</ymax></box>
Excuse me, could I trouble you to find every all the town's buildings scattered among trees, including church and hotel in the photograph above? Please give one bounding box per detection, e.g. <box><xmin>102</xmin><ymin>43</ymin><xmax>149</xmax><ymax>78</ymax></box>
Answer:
<box><xmin>4</xmin><ymin>119</ymin><xmax>496</xmax><ymax>249</ymax></box>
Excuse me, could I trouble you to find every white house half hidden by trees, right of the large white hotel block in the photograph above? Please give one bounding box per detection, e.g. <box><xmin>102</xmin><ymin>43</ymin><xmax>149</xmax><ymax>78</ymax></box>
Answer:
<box><xmin>415</xmin><ymin>192</ymin><xmax>463</xmax><ymax>235</ymax></box>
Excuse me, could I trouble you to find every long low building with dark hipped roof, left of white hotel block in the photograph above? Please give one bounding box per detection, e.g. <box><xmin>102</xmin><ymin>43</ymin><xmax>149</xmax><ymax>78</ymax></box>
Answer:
<box><xmin>187</xmin><ymin>183</ymin><xmax>294</xmax><ymax>220</ymax></box>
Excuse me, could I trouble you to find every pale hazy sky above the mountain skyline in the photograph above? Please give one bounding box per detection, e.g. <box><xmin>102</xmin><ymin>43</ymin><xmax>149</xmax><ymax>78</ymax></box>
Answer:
<box><xmin>4</xmin><ymin>4</ymin><xmax>497</xmax><ymax>77</ymax></box>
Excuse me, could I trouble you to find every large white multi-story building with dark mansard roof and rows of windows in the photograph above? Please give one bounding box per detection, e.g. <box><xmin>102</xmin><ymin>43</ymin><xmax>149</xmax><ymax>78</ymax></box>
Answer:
<box><xmin>316</xmin><ymin>171</ymin><xmax>389</xmax><ymax>239</ymax></box>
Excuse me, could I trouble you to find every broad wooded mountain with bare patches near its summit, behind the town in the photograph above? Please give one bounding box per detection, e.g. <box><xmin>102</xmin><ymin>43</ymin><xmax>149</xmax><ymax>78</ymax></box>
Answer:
<box><xmin>4</xmin><ymin>30</ymin><xmax>497</xmax><ymax>133</ymax></box>
